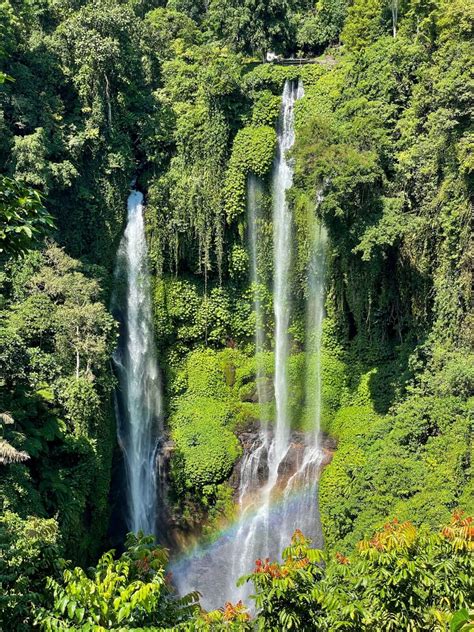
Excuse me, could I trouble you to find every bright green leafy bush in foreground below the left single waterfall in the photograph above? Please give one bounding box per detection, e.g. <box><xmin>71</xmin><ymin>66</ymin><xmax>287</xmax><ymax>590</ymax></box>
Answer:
<box><xmin>37</xmin><ymin>534</ymin><xmax>197</xmax><ymax>631</ymax></box>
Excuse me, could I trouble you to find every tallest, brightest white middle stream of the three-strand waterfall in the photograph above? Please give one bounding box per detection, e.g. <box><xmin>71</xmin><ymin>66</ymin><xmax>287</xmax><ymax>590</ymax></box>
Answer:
<box><xmin>226</xmin><ymin>81</ymin><xmax>304</xmax><ymax>598</ymax></box>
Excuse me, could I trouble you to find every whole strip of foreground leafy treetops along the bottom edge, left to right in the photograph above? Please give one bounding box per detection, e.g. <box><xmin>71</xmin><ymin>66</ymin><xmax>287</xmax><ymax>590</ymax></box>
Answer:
<box><xmin>37</xmin><ymin>514</ymin><xmax>474</xmax><ymax>632</ymax></box>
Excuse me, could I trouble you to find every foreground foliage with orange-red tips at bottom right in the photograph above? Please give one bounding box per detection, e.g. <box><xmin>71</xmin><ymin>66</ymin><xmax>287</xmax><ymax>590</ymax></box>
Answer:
<box><xmin>240</xmin><ymin>513</ymin><xmax>473</xmax><ymax>632</ymax></box>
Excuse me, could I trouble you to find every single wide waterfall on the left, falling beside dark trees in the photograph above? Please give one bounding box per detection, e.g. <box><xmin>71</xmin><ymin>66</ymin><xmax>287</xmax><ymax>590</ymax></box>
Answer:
<box><xmin>113</xmin><ymin>191</ymin><xmax>162</xmax><ymax>534</ymax></box>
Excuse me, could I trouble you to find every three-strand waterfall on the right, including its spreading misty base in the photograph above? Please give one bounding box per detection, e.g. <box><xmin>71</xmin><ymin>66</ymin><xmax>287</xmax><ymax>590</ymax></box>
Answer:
<box><xmin>172</xmin><ymin>81</ymin><xmax>325</xmax><ymax>609</ymax></box>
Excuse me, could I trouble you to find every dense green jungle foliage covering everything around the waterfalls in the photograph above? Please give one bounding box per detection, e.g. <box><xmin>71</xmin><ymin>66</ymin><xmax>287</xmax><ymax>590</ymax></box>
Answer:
<box><xmin>0</xmin><ymin>0</ymin><xmax>474</xmax><ymax>630</ymax></box>
